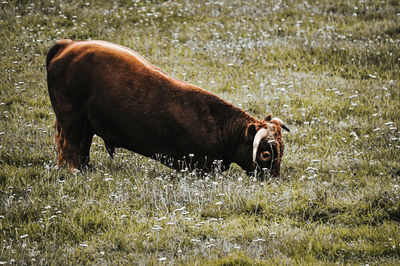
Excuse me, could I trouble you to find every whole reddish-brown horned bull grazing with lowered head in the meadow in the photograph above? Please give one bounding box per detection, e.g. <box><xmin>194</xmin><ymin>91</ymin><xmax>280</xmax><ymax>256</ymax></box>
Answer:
<box><xmin>46</xmin><ymin>39</ymin><xmax>289</xmax><ymax>176</ymax></box>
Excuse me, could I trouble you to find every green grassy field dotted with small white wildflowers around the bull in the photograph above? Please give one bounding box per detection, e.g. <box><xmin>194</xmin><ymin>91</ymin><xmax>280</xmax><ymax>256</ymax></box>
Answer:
<box><xmin>0</xmin><ymin>0</ymin><xmax>400</xmax><ymax>265</ymax></box>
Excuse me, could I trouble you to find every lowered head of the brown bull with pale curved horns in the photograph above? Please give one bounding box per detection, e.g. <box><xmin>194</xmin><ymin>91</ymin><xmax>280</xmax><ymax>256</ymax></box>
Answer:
<box><xmin>245</xmin><ymin>114</ymin><xmax>290</xmax><ymax>177</ymax></box>
